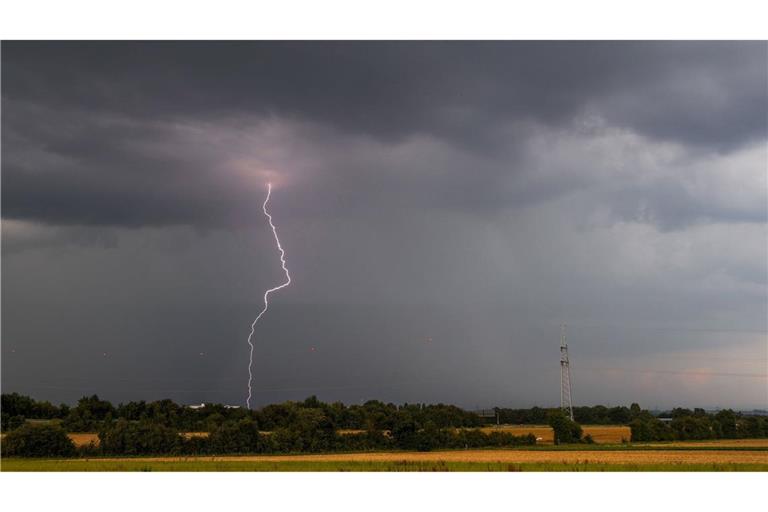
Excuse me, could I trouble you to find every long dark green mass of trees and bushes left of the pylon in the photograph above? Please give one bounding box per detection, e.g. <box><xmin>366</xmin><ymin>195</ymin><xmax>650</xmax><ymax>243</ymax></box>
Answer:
<box><xmin>2</xmin><ymin>394</ymin><xmax>536</xmax><ymax>457</ymax></box>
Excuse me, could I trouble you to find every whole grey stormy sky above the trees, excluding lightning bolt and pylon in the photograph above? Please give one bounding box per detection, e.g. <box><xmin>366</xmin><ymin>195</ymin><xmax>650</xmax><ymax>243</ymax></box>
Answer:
<box><xmin>2</xmin><ymin>42</ymin><xmax>768</xmax><ymax>408</ymax></box>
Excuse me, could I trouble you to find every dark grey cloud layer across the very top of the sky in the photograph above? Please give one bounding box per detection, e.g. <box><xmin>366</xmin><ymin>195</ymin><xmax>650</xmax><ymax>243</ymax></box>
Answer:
<box><xmin>3</xmin><ymin>42</ymin><xmax>766</xmax><ymax>147</ymax></box>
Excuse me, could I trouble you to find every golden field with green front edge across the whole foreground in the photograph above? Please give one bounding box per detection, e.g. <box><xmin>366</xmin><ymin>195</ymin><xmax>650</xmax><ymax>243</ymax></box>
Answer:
<box><xmin>0</xmin><ymin>439</ymin><xmax>768</xmax><ymax>471</ymax></box>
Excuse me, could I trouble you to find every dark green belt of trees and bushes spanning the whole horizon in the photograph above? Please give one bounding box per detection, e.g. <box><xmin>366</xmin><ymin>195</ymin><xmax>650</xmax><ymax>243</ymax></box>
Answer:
<box><xmin>0</xmin><ymin>393</ymin><xmax>768</xmax><ymax>457</ymax></box>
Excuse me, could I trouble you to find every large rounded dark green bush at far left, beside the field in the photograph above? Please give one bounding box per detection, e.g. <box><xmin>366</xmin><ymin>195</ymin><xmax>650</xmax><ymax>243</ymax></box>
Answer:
<box><xmin>2</xmin><ymin>423</ymin><xmax>75</xmax><ymax>457</ymax></box>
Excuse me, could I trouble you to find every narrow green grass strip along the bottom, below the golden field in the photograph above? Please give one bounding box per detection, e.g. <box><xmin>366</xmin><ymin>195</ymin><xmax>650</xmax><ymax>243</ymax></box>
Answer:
<box><xmin>0</xmin><ymin>459</ymin><xmax>768</xmax><ymax>472</ymax></box>
